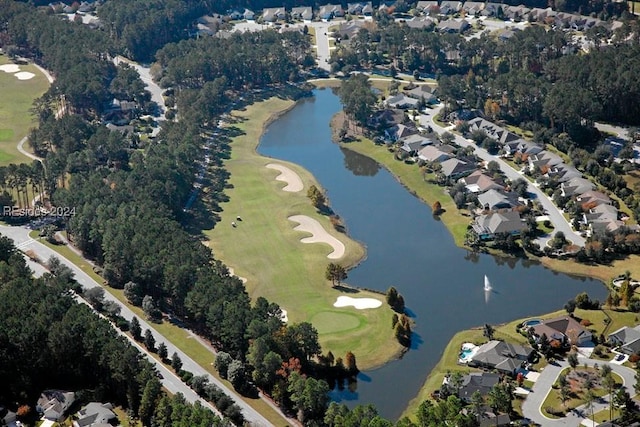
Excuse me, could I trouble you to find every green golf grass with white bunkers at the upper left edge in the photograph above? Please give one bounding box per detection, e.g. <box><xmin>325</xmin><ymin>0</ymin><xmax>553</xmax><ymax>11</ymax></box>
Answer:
<box><xmin>0</xmin><ymin>55</ymin><xmax>49</xmax><ymax>166</ymax></box>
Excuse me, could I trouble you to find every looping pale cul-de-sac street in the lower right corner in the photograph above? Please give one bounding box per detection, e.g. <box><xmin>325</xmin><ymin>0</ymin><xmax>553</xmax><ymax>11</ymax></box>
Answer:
<box><xmin>522</xmin><ymin>356</ymin><xmax>635</xmax><ymax>427</ymax></box>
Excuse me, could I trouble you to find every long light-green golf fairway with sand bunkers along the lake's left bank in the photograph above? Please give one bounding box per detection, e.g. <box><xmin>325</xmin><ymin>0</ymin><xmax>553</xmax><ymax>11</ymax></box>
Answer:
<box><xmin>205</xmin><ymin>98</ymin><xmax>401</xmax><ymax>368</ymax></box>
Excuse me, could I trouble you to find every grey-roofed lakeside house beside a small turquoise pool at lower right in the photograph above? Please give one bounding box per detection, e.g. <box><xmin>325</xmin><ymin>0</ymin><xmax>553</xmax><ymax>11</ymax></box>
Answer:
<box><xmin>468</xmin><ymin>340</ymin><xmax>533</xmax><ymax>375</ymax></box>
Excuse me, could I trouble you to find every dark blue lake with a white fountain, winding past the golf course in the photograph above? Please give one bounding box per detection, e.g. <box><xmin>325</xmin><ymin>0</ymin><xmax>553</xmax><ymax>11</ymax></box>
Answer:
<box><xmin>258</xmin><ymin>90</ymin><xmax>606</xmax><ymax>418</ymax></box>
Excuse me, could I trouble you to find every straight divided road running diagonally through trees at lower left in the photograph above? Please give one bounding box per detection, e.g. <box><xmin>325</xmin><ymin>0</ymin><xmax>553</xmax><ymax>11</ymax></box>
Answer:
<box><xmin>0</xmin><ymin>225</ymin><xmax>271</xmax><ymax>426</ymax></box>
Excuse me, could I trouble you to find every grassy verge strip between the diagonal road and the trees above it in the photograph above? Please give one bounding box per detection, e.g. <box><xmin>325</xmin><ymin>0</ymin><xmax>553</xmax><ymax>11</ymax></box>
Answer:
<box><xmin>29</xmin><ymin>231</ymin><xmax>287</xmax><ymax>426</ymax></box>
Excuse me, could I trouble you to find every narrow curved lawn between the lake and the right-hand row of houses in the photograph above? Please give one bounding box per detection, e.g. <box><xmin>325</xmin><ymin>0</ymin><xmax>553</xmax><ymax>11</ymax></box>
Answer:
<box><xmin>342</xmin><ymin>138</ymin><xmax>471</xmax><ymax>246</ymax></box>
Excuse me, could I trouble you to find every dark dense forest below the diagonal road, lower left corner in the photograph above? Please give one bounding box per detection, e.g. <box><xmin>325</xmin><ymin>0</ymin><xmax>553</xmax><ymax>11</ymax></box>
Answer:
<box><xmin>0</xmin><ymin>236</ymin><xmax>221</xmax><ymax>427</ymax></box>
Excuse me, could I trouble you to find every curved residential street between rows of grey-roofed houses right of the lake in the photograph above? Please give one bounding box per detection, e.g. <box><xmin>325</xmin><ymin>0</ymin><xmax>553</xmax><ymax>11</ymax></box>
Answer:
<box><xmin>419</xmin><ymin>106</ymin><xmax>585</xmax><ymax>246</ymax></box>
